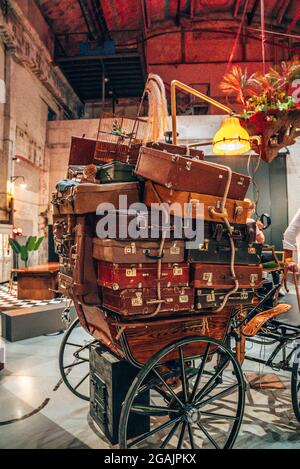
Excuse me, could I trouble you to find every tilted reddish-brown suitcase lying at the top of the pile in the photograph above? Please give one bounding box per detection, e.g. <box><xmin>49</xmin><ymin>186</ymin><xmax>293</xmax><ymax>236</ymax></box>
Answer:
<box><xmin>136</xmin><ymin>147</ymin><xmax>251</xmax><ymax>200</ymax></box>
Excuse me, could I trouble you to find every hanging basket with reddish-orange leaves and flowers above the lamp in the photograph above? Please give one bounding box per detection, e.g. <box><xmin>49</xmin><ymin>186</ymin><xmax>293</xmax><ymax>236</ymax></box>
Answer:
<box><xmin>220</xmin><ymin>62</ymin><xmax>300</xmax><ymax>162</ymax></box>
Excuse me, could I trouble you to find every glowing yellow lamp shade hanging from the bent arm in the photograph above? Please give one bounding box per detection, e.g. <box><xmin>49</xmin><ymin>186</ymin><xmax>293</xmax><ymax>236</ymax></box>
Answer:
<box><xmin>213</xmin><ymin>117</ymin><xmax>251</xmax><ymax>155</ymax></box>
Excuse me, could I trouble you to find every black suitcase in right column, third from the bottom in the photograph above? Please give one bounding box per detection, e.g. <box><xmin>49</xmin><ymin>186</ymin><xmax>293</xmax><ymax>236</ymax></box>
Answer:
<box><xmin>187</xmin><ymin>239</ymin><xmax>263</xmax><ymax>265</ymax></box>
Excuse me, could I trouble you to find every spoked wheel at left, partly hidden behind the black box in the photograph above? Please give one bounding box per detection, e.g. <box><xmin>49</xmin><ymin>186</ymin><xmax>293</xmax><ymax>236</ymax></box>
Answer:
<box><xmin>59</xmin><ymin>318</ymin><xmax>96</xmax><ymax>401</ymax></box>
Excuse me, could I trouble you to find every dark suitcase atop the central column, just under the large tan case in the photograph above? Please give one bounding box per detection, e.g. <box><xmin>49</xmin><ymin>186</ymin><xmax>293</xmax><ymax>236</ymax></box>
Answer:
<box><xmin>96</xmin><ymin>209</ymin><xmax>183</xmax><ymax>240</ymax></box>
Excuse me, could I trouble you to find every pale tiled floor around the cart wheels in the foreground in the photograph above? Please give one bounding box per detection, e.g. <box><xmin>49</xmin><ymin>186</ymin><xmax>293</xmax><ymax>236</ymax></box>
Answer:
<box><xmin>0</xmin><ymin>286</ymin><xmax>300</xmax><ymax>448</ymax></box>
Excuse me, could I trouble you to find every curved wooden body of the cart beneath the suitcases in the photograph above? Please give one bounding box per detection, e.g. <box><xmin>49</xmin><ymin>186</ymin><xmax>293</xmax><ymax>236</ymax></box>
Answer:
<box><xmin>108</xmin><ymin>306</ymin><xmax>232</xmax><ymax>365</ymax></box>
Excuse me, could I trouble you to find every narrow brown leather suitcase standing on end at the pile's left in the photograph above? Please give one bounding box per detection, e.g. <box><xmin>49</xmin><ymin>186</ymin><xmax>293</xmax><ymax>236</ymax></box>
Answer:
<box><xmin>72</xmin><ymin>216</ymin><xmax>101</xmax><ymax>305</ymax></box>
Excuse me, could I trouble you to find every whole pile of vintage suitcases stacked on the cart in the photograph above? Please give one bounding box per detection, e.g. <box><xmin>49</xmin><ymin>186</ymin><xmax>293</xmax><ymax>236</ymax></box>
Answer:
<box><xmin>52</xmin><ymin>132</ymin><xmax>262</xmax><ymax>363</ymax></box>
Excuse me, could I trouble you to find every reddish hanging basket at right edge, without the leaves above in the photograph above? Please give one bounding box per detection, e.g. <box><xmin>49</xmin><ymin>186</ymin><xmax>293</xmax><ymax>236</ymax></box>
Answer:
<box><xmin>240</xmin><ymin>108</ymin><xmax>300</xmax><ymax>163</ymax></box>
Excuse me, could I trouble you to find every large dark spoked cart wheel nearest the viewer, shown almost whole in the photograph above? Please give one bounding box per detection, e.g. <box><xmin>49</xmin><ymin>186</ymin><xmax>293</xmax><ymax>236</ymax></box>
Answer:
<box><xmin>119</xmin><ymin>337</ymin><xmax>245</xmax><ymax>449</ymax></box>
